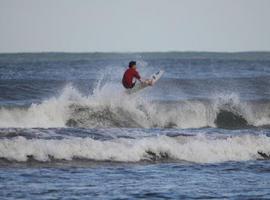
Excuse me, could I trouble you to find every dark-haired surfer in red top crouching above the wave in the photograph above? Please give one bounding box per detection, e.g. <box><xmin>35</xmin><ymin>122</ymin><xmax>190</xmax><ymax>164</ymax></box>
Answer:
<box><xmin>122</xmin><ymin>61</ymin><xmax>152</xmax><ymax>89</ymax></box>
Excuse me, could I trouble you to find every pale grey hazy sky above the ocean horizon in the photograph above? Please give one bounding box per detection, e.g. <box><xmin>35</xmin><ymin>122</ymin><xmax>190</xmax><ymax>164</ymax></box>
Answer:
<box><xmin>0</xmin><ymin>0</ymin><xmax>270</xmax><ymax>52</ymax></box>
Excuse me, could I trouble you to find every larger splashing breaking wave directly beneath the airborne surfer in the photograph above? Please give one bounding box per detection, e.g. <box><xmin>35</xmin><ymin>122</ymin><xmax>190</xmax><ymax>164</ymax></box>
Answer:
<box><xmin>0</xmin><ymin>84</ymin><xmax>270</xmax><ymax>129</ymax></box>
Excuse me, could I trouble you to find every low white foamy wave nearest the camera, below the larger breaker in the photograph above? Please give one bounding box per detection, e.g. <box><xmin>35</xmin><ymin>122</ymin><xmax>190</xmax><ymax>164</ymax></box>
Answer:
<box><xmin>0</xmin><ymin>135</ymin><xmax>270</xmax><ymax>163</ymax></box>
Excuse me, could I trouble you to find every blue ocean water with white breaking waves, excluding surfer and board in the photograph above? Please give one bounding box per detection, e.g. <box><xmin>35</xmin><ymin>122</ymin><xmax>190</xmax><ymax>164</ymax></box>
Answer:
<box><xmin>0</xmin><ymin>52</ymin><xmax>270</xmax><ymax>199</ymax></box>
